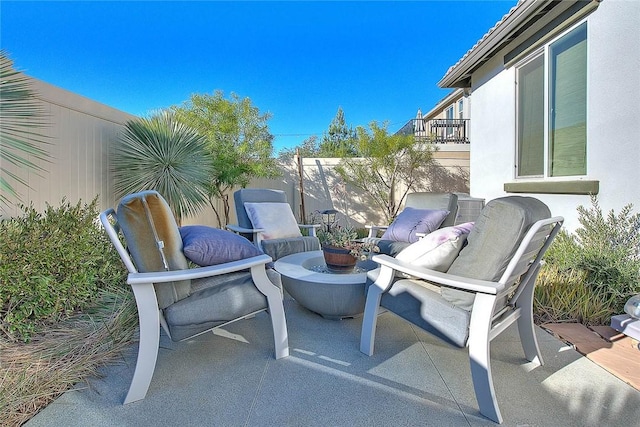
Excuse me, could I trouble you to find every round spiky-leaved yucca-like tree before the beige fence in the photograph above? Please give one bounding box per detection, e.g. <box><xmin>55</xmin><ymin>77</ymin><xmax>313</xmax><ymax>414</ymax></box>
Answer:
<box><xmin>112</xmin><ymin>111</ymin><xmax>213</xmax><ymax>223</ymax></box>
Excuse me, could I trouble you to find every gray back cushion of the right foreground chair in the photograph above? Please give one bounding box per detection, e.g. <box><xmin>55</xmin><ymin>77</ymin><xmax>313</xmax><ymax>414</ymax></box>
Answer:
<box><xmin>441</xmin><ymin>196</ymin><xmax>551</xmax><ymax>310</ymax></box>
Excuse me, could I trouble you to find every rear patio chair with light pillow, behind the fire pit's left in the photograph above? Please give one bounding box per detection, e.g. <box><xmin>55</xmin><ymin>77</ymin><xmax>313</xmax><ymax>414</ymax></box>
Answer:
<box><xmin>227</xmin><ymin>188</ymin><xmax>320</xmax><ymax>261</ymax></box>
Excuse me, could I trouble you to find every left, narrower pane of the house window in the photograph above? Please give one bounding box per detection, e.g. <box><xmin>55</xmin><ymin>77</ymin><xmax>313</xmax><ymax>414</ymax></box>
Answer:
<box><xmin>518</xmin><ymin>56</ymin><xmax>544</xmax><ymax>176</ymax></box>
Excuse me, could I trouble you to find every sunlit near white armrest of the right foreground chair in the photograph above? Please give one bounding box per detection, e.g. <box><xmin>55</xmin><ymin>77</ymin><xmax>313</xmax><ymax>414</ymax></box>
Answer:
<box><xmin>371</xmin><ymin>255</ymin><xmax>505</xmax><ymax>295</ymax></box>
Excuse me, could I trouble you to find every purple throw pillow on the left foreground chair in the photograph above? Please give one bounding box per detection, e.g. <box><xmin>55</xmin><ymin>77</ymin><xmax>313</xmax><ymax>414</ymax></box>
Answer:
<box><xmin>180</xmin><ymin>225</ymin><xmax>263</xmax><ymax>267</ymax></box>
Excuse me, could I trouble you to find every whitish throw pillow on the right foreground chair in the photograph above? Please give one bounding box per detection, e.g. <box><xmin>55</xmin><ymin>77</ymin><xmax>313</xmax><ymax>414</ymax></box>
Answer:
<box><xmin>396</xmin><ymin>222</ymin><xmax>473</xmax><ymax>272</ymax></box>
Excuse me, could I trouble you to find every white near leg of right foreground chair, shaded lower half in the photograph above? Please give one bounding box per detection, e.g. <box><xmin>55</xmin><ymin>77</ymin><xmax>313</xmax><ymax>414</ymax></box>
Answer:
<box><xmin>469</xmin><ymin>293</ymin><xmax>502</xmax><ymax>423</ymax></box>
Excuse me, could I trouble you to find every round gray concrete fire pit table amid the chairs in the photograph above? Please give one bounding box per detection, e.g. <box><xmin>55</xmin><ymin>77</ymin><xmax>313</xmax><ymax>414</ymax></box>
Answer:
<box><xmin>275</xmin><ymin>251</ymin><xmax>378</xmax><ymax>320</ymax></box>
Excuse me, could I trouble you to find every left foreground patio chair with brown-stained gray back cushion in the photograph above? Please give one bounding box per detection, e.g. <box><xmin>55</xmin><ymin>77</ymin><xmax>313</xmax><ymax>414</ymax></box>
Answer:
<box><xmin>100</xmin><ymin>191</ymin><xmax>289</xmax><ymax>404</ymax></box>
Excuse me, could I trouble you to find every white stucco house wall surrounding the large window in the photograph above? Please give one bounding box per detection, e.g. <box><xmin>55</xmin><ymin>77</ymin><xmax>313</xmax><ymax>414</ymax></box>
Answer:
<box><xmin>452</xmin><ymin>0</ymin><xmax>640</xmax><ymax>230</ymax></box>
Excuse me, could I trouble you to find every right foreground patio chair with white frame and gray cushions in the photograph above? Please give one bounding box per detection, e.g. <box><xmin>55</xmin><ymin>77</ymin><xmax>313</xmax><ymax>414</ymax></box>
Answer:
<box><xmin>360</xmin><ymin>196</ymin><xmax>564</xmax><ymax>423</ymax></box>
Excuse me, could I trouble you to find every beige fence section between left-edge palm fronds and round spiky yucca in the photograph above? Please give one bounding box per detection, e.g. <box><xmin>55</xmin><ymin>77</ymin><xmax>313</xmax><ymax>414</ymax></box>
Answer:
<box><xmin>0</xmin><ymin>74</ymin><xmax>135</xmax><ymax>217</ymax></box>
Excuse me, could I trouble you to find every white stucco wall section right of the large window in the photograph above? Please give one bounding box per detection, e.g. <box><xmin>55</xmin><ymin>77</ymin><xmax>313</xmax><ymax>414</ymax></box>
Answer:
<box><xmin>587</xmin><ymin>0</ymin><xmax>640</xmax><ymax>222</ymax></box>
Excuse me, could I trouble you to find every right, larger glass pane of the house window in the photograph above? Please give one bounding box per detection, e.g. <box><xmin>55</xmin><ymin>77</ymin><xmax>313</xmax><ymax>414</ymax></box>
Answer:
<box><xmin>549</xmin><ymin>24</ymin><xmax>587</xmax><ymax>176</ymax></box>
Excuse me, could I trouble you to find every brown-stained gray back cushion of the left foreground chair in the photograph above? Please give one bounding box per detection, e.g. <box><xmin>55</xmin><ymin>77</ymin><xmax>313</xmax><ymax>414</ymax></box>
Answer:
<box><xmin>116</xmin><ymin>191</ymin><xmax>191</xmax><ymax>308</ymax></box>
